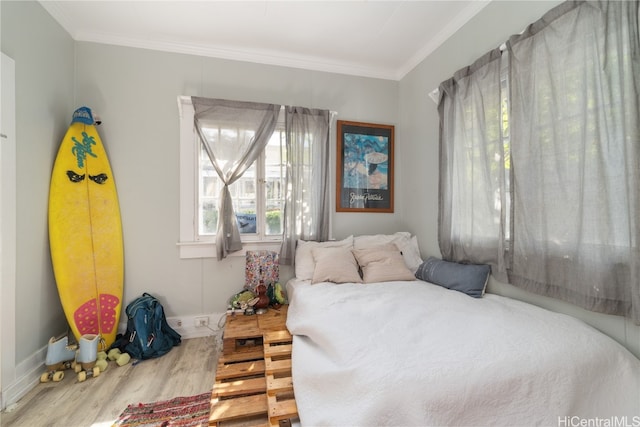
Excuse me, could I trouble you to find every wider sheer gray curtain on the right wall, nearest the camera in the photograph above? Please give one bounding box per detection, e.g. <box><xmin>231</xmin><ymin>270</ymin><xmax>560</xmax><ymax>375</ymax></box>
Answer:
<box><xmin>507</xmin><ymin>1</ymin><xmax>640</xmax><ymax>322</ymax></box>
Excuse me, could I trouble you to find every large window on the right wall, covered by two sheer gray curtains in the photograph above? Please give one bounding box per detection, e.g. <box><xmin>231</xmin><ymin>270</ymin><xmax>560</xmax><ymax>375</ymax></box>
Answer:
<box><xmin>439</xmin><ymin>2</ymin><xmax>640</xmax><ymax>322</ymax></box>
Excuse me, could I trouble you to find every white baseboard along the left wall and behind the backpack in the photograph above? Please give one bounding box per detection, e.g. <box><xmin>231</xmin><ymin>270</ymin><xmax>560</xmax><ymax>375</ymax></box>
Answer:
<box><xmin>0</xmin><ymin>313</ymin><xmax>226</xmax><ymax>410</ymax></box>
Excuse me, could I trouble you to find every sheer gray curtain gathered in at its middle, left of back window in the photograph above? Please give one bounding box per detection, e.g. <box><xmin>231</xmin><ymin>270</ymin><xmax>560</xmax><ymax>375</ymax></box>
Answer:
<box><xmin>191</xmin><ymin>97</ymin><xmax>280</xmax><ymax>260</ymax></box>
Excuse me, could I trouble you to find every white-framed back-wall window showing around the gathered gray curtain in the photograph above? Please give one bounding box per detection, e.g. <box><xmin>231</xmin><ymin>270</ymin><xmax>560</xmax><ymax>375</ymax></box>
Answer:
<box><xmin>178</xmin><ymin>97</ymin><xmax>286</xmax><ymax>258</ymax></box>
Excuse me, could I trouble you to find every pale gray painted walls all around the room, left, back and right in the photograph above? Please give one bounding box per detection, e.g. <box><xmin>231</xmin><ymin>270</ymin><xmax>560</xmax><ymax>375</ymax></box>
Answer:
<box><xmin>1</xmin><ymin>1</ymin><xmax>640</xmax><ymax>418</ymax></box>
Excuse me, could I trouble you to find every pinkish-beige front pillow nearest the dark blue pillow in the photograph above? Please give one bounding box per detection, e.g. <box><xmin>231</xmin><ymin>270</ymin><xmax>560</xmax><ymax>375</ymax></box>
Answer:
<box><xmin>352</xmin><ymin>243</ymin><xmax>416</xmax><ymax>283</ymax></box>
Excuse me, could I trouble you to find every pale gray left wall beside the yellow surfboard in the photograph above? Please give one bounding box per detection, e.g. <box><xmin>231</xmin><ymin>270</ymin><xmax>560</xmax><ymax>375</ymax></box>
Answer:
<box><xmin>0</xmin><ymin>1</ymin><xmax>75</xmax><ymax>404</ymax></box>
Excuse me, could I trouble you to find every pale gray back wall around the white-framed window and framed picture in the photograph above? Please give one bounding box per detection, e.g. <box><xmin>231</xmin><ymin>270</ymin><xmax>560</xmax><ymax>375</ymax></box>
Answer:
<box><xmin>76</xmin><ymin>42</ymin><xmax>400</xmax><ymax>316</ymax></box>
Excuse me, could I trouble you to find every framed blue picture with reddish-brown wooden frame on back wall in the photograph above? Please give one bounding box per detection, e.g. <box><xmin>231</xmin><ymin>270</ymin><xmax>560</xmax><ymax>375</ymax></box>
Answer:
<box><xmin>336</xmin><ymin>120</ymin><xmax>394</xmax><ymax>212</ymax></box>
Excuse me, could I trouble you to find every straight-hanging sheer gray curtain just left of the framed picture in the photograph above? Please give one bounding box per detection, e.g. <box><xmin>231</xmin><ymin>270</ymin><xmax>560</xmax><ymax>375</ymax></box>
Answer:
<box><xmin>280</xmin><ymin>107</ymin><xmax>331</xmax><ymax>265</ymax></box>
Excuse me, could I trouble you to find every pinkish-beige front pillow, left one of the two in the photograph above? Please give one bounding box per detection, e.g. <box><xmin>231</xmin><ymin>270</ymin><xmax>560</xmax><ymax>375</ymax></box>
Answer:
<box><xmin>311</xmin><ymin>247</ymin><xmax>362</xmax><ymax>283</ymax></box>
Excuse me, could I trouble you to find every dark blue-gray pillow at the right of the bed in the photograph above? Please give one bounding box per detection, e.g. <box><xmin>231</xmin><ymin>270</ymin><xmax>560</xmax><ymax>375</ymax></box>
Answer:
<box><xmin>416</xmin><ymin>257</ymin><xmax>491</xmax><ymax>298</ymax></box>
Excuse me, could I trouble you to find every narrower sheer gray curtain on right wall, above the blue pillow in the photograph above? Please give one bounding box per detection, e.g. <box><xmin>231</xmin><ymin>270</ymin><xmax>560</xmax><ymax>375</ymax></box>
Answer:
<box><xmin>438</xmin><ymin>49</ymin><xmax>508</xmax><ymax>280</ymax></box>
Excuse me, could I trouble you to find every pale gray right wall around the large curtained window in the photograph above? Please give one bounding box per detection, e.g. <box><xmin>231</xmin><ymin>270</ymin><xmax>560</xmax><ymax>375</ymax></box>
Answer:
<box><xmin>399</xmin><ymin>0</ymin><xmax>640</xmax><ymax>357</ymax></box>
